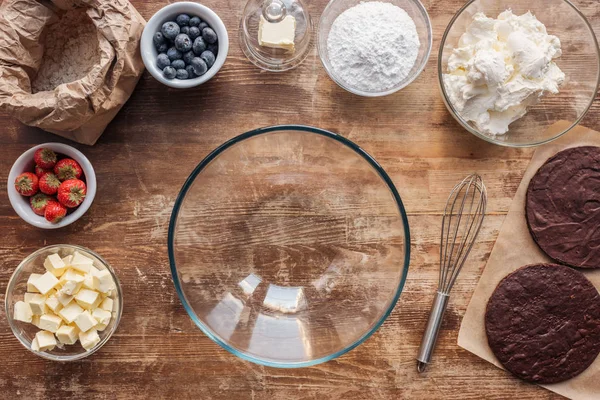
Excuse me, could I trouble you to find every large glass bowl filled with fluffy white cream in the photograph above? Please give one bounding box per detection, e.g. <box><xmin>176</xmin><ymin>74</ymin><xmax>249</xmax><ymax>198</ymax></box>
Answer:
<box><xmin>438</xmin><ymin>0</ymin><xmax>600</xmax><ymax>147</ymax></box>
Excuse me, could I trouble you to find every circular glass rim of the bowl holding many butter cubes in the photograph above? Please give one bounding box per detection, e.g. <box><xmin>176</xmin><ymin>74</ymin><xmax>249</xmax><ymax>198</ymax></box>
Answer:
<box><xmin>4</xmin><ymin>243</ymin><xmax>123</xmax><ymax>362</ymax></box>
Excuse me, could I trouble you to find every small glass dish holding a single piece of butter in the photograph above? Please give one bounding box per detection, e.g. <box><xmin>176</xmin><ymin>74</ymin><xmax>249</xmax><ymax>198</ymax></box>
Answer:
<box><xmin>239</xmin><ymin>0</ymin><xmax>313</xmax><ymax>72</ymax></box>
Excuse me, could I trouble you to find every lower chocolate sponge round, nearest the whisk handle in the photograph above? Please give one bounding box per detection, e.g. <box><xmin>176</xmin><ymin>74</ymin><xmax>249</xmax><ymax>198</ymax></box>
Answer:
<box><xmin>485</xmin><ymin>264</ymin><xmax>600</xmax><ymax>384</ymax></box>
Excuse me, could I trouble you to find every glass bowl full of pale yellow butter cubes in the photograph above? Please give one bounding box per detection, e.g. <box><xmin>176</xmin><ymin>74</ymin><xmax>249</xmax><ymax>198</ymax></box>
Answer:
<box><xmin>5</xmin><ymin>245</ymin><xmax>123</xmax><ymax>361</ymax></box>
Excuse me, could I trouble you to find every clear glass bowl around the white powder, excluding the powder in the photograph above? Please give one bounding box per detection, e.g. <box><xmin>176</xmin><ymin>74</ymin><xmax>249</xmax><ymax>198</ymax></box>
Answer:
<box><xmin>317</xmin><ymin>0</ymin><xmax>433</xmax><ymax>97</ymax></box>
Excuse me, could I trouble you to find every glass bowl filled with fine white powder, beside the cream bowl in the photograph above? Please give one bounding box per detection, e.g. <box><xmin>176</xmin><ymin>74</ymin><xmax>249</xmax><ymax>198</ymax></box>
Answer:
<box><xmin>317</xmin><ymin>0</ymin><xmax>432</xmax><ymax>97</ymax></box>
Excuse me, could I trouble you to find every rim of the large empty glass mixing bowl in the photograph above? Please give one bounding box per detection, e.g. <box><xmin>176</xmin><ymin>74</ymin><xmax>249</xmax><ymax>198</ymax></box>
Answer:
<box><xmin>168</xmin><ymin>125</ymin><xmax>410</xmax><ymax>368</ymax></box>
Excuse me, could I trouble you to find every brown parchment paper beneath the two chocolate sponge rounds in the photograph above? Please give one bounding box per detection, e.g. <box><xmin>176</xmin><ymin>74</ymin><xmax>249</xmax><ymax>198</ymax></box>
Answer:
<box><xmin>458</xmin><ymin>122</ymin><xmax>600</xmax><ymax>400</ymax></box>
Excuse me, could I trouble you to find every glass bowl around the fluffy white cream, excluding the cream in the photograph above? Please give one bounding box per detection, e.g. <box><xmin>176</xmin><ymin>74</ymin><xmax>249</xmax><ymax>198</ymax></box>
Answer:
<box><xmin>438</xmin><ymin>0</ymin><xmax>600</xmax><ymax>147</ymax></box>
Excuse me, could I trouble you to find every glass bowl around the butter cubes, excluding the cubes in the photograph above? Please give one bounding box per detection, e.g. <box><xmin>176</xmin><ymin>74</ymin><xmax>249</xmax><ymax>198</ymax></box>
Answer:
<box><xmin>4</xmin><ymin>244</ymin><xmax>123</xmax><ymax>361</ymax></box>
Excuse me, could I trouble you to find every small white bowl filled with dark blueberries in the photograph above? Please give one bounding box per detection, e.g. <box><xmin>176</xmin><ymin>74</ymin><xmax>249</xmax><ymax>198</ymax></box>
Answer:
<box><xmin>140</xmin><ymin>2</ymin><xmax>229</xmax><ymax>89</ymax></box>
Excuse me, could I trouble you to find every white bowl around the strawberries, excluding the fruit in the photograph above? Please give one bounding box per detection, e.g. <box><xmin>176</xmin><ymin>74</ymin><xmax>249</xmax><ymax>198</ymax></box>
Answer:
<box><xmin>6</xmin><ymin>143</ymin><xmax>96</xmax><ymax>229</ymax></box>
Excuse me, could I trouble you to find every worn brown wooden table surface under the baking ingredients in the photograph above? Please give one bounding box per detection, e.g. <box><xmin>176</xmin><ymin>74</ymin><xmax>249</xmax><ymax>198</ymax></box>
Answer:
<box><xmin>0</xmin><ymin>0</ymin><xmax>600</xmax><ymax>400</ymax></box>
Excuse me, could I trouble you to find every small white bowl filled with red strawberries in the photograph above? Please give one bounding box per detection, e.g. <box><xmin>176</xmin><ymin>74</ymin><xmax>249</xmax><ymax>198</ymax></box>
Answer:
<box><xmin>7</xmin><ymin>143</ymin><xmax>96</xmax><ymax>229</ymax></box>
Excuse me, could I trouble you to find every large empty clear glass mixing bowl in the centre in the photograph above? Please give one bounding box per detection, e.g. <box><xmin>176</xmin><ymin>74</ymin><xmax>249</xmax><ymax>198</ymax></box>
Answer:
<box><xmin>169</xmin><ymin>126</ymin><xmax>410</xmax><ymax>367</ymax></box>
